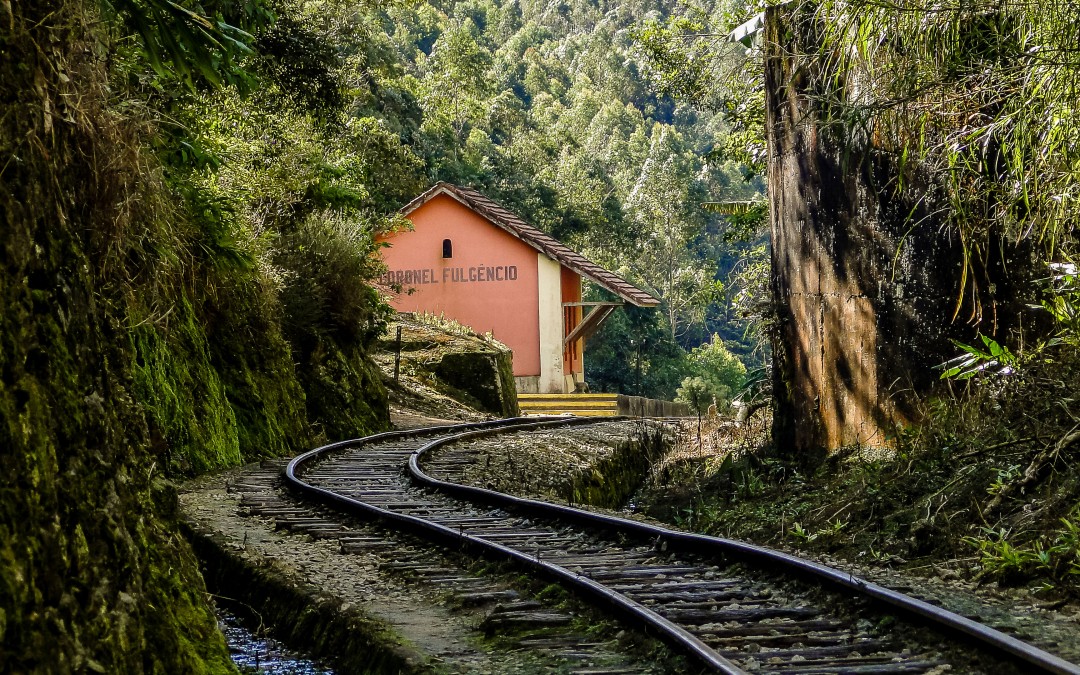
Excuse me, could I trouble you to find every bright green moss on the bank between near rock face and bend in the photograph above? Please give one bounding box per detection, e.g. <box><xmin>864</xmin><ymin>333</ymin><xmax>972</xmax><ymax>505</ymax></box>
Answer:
<box><xmin>132</xmin><ymin>265</ymin><xmax>324</xmax><ymax>475</ymax></box>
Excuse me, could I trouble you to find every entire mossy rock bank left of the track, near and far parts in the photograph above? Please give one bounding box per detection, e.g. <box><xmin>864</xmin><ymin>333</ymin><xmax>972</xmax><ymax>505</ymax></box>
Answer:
<box><xmin>0</xmin><ymin>0</ymin><xmax>388</xmax><ymax>675</ymax></box>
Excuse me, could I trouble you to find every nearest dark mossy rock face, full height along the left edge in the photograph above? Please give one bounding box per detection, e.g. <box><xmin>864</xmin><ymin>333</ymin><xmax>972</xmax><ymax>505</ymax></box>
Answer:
<box><xmin>0</xmin><ymin>0</ymin><xmax>234</xmax><ymax>674</ymax></box>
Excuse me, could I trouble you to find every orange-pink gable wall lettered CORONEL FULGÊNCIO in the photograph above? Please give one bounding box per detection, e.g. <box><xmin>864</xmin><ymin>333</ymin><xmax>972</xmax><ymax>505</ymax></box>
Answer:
<box><xmin>380</xmin><ymin>194</ymin><xmax>540</xmax><ymax>377</ymax></box>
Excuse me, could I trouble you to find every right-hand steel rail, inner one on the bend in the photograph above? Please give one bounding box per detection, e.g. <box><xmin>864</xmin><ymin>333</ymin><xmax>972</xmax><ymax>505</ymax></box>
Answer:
<box><xmin>408</xmin><ymin>418</ymin><xmax>1080</xmax><ymax>675</ymax></box>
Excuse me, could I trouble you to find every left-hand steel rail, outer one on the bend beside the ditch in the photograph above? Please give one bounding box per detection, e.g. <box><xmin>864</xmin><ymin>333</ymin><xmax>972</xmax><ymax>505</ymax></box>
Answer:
<box><xmin>284</xmin><ymin>417</ymin><xmax>748</xmax><ymax>675</ymax></box>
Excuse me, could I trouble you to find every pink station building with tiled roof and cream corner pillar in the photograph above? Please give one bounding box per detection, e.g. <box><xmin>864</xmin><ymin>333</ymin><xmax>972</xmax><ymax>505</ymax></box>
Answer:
<box><xmin>380</xmin><ymin>183</ymin><xmax>660</xmax><ymax>393</ymax></box>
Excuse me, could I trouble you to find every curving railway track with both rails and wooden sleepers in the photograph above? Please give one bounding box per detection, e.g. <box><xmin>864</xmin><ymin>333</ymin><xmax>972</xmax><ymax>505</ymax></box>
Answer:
<box><xmin>284</xmin><ymin>418</ymin><xmax>1080</xmax><ymax>675</ymax></box>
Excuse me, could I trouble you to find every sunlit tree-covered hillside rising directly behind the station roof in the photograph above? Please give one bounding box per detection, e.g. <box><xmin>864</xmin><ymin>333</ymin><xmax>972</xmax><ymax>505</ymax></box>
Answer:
<box><xmin>262</xmin><ymin>0</ymin><xmax>765</xmax><ymax>399</ymax></box>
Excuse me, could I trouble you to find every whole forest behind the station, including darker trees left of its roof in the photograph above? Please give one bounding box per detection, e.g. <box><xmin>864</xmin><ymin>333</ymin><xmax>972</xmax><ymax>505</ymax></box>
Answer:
<box><xmin>170</xmin><ymin>2</ymin><xmax>764</xmax><ymax>399</ymax></box>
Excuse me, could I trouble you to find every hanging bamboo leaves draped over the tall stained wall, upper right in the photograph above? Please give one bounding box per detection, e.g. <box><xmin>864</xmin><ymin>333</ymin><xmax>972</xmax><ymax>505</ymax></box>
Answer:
<box><xmin>813</xmin><ymin>0</ymin><xmax>1080</xmax><ymax>291</ymax></box>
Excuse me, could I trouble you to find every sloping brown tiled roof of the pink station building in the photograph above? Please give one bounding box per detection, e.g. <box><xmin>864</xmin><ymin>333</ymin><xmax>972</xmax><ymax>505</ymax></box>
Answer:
<box><xmin>400</xmin><ymin>183</ymin><xmax>660</xmax><ymax>307</ymax></box>
